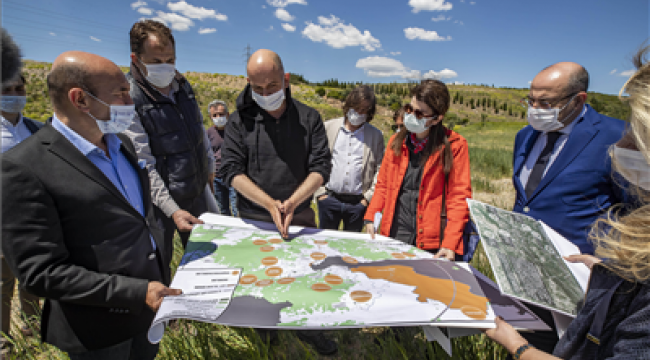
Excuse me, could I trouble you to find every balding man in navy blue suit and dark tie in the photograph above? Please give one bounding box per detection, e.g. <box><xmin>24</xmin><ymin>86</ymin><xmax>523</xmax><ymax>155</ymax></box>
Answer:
<box><xmin>512</xmin><ymin>62</ymin><xmax>625</xmax><ymax>353</ymax></box>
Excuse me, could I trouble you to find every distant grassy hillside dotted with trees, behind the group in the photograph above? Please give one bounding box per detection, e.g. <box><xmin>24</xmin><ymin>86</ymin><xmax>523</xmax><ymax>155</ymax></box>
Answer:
<box><xmin>23</xmin><ymin>60</ymin><xmax>629</xmax><ymax>135</ymax></box>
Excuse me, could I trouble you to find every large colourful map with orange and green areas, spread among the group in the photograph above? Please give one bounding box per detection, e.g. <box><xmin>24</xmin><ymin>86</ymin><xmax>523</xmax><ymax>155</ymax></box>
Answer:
<box><xmin>146</xmin><ymin>215</ymin><xmax>546</xmax><ymax>344</ymax></box>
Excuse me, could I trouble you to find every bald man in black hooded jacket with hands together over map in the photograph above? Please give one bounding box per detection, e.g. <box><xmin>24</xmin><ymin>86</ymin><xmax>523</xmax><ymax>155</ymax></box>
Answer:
<box><xmin>218</xmin><ymin>50</ymin><xmax>337</xmax><ymax>354</ymax></box>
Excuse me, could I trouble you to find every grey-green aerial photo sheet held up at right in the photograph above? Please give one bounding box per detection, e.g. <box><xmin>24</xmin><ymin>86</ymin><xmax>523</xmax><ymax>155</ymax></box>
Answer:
<box><xmin>467</xmin><ymin>200</ymin><xmax>584</xmax><ymax>317</ymax></box>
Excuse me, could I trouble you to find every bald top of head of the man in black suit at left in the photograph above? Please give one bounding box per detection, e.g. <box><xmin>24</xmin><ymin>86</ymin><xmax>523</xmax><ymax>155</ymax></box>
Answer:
<box><xmin>47</xmin><ymin>51</ymin><xmax>124</xmax><ymax>109</ymax></box>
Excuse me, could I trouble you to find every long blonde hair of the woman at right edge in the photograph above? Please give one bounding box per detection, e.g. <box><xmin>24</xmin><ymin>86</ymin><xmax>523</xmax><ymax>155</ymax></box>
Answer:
<box><xmin>591</xmin><ymin>46</ymin><xmax>650</xmax><ymax>282</ymax></box>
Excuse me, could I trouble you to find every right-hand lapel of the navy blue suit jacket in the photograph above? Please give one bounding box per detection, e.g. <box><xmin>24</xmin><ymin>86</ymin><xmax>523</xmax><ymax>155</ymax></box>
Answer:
<box><xmin>528</xmin><ymin>115</ymin><xmax>599</xmax><ymax>201</ymax></box>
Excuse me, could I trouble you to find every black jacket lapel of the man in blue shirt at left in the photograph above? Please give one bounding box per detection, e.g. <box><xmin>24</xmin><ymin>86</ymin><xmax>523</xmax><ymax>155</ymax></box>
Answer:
<box><xmin>41</xmin><ymin>126</ymin><xmax>135</xmax><ymax>211</ymax></box>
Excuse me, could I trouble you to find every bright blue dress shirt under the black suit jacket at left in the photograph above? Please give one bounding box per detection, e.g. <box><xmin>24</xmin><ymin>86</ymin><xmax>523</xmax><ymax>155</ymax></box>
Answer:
<box><xmin>52</xmin><ymin>114</ymin><xmax>156</xmax><ymax>250</ymax></box>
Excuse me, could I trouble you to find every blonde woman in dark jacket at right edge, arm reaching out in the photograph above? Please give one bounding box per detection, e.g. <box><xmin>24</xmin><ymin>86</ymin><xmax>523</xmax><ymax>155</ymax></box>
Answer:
<box><xmin>485</xmin><ymin>46</ymin><xmax>650</xmax><ymax>360</ymax></box>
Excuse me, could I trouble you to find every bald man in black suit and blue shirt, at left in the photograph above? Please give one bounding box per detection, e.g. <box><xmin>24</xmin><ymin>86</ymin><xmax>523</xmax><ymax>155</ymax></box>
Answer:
<box><xmin>2</xmin><ymin>51</ymin><xmax>180</xmax><ymax>360</ymax></box>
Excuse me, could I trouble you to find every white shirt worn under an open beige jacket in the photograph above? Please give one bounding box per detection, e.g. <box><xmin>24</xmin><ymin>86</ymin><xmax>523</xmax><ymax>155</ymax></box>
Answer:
<box><xmin>325</xmin><ymin>122</ymin><xmax>365</xmax><ymax>195</ymax></box>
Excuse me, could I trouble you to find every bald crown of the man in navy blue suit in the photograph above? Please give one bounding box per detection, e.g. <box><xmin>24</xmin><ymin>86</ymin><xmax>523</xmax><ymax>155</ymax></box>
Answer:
<box><xmin>531</xmin><ymin>62</ymin><xmax>589</xmax><ymax>95</ymax></box>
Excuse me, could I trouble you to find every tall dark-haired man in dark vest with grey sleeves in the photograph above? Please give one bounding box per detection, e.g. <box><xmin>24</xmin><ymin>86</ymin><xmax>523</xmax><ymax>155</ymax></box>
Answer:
<box><xmin>125</xmin><ymin>20</ymin><xmax>216</xmax><ymax>249</ymax></box>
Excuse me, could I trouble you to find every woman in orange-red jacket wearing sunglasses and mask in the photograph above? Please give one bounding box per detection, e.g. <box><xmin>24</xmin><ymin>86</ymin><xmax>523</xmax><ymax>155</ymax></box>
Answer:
<box><xmin>365</xmin><ymin>80</ymin><xmax>472</xmax><ymax>260</ymax></box>
